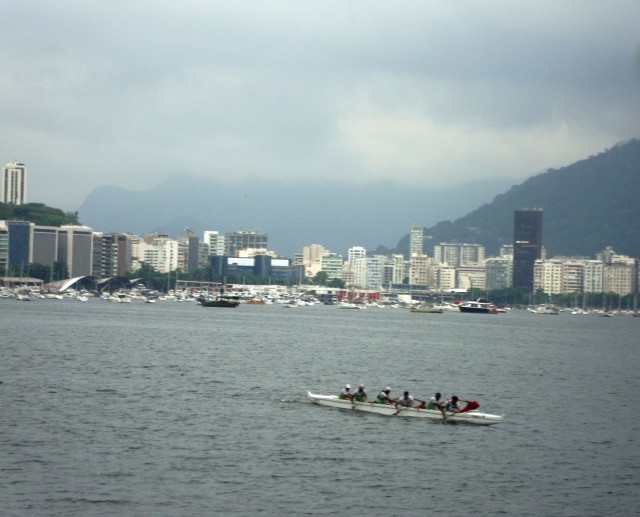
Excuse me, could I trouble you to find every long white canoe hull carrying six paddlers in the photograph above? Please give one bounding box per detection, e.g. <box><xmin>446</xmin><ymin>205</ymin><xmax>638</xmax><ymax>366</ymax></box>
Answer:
<box><xmin>307</xmin><ymin>391</ymin><xmax>504</xmax><ymax>425</ymax></box>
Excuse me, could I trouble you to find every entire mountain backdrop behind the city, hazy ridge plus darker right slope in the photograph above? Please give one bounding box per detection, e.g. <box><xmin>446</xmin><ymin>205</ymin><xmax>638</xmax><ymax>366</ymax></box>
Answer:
<box><xmin>79</xmin><ymin>140</ymin><xmax>640</xmax><ymax>257</ymax></box>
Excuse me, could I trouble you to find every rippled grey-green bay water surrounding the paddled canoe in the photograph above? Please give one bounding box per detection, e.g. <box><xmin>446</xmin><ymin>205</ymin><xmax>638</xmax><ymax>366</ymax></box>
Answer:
<box><xmin>0</xmin><ymin>299</ymin><xmax>640</xmax><ymax>516</ymax></box>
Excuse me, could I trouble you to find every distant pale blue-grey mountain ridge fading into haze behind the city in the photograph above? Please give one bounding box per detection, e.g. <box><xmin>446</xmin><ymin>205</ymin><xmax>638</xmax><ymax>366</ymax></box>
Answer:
<box><xmin>79</xmin><ymin>176</ymin><xmax>514</xmax><ymax>257</ymax></box>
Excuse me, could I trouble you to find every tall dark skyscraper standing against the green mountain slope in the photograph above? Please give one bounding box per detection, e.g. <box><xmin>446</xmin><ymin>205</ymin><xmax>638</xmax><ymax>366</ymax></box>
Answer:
<box><xmin>512</xmin><ymin>208</ymin><xmax>542</xmax><ymax>293</ymax></box>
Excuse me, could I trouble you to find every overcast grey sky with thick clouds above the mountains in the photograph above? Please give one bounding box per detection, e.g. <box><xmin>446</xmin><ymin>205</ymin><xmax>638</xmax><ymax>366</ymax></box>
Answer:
<box><xmin>0</xmin><ymin>0</ymin><xmax>640</xmax><ymax>210</ymax></box>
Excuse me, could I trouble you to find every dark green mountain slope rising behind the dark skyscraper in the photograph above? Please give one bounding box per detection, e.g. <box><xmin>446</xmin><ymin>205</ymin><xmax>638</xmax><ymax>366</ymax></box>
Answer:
<box><xmin>397</xmin><ymin>139</ymin><xmax>640</xmax><ymax>257</ymax></box>
